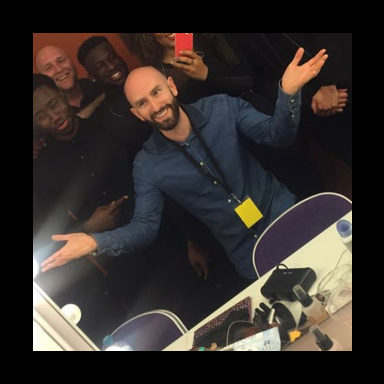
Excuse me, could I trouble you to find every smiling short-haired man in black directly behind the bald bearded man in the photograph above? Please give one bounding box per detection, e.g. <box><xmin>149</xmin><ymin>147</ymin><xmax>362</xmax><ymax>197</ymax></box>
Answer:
<box><xmin>77</xmin><ymin>36</ymin><xmax>213</xmax><ymax>280</ymax></box>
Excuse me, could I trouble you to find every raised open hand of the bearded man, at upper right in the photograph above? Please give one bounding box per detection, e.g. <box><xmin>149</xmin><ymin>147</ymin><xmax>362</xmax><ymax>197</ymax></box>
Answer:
<box><xmin>282</xmin><ymin>48</ymin><xmax>328</xmax><ymax>95</ymax></box>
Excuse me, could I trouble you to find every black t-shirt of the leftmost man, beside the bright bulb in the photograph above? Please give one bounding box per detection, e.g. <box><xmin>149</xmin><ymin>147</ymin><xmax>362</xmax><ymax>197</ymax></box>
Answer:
<box><xmin>33</xmin><ymin>120</ymin><xmax>135</xmax><ymax>243</ymax></box>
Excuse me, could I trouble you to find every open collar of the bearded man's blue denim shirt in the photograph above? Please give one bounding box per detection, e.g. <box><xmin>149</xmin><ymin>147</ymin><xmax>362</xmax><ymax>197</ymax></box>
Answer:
<box><xmin>145</xmin><ymin>105</ymin><xmax>208</xmax><ymax>154</ymax></box>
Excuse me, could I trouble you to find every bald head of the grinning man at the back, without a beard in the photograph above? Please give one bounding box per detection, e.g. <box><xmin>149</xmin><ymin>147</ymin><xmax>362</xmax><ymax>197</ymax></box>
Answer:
<box><xmin>35</xmin><ymin>45</ymin><xmax>77</xmax><ymax>92</ymax></box>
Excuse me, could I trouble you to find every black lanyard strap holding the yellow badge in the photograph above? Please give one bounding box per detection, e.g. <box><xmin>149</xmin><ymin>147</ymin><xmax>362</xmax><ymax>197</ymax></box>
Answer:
<box><xmin>164</xmin><ymin>127</ymin><xmax>242</xmax><ymax>204</ymax></box>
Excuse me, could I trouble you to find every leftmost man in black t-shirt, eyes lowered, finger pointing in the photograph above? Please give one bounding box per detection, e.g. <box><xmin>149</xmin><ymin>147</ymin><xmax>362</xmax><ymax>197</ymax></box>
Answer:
<box><xmin>33</xmin><ymin>74</ymin><xmax>133</xmax><ymax>250</ymax></box>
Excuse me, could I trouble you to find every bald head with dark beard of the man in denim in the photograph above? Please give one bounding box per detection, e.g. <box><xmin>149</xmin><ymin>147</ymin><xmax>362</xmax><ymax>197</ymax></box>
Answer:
<box><xmin>124</xmin><ymin>67</ymin><xmax>180</xmax><ymax>131</ymax></box>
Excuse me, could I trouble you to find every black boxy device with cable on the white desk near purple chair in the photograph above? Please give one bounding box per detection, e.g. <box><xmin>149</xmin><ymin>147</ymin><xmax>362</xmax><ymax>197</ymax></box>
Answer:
<box><xmin>260</xmin><ymin>264</ymin><xmax>316</xmax><ymax>301</ymax></box>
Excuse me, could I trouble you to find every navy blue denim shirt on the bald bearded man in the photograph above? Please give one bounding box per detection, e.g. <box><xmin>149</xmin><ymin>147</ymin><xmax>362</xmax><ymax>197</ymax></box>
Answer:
<box><xmin>93</xmin><ymin>90</ymin><xmax>301</xmax><ymax>278</ymax></box>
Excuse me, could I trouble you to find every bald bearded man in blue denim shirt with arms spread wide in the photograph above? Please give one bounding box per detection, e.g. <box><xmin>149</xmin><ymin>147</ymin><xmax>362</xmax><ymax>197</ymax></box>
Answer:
<box><xmin>43</xmin><ymin>48</ymin><xmax>328</xmax><ymax>279</ymax></box>
